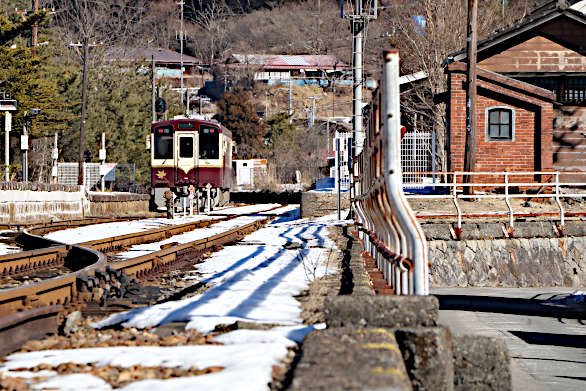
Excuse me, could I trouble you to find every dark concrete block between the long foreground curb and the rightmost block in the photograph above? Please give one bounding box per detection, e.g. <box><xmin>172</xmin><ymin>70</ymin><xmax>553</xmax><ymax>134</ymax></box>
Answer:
<box><xmin>395</xmin><ymin>327</ymin><xmax>454</xmax><ymax>391</ymax></box>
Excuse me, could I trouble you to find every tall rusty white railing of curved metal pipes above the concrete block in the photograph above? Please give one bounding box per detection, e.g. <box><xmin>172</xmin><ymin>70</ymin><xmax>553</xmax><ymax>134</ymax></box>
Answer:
<box><xmin>353</xmin><ymin>50</ymin><xmax>429</xmax><ymax>295</ymax></box>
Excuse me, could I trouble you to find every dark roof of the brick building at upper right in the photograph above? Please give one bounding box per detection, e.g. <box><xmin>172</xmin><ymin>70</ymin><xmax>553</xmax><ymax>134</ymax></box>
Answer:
<box><xmin>444</xmin><ymin>0</ymin><xmax>586</xmax><ymax>64</ymax></box>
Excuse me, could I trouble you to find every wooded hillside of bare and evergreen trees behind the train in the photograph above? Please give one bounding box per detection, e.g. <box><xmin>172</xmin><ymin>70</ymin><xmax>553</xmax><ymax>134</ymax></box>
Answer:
<box><xmin>0</xmin><ymin>0</ymin><xmax>534</xmax><ymax>189</ymax></box>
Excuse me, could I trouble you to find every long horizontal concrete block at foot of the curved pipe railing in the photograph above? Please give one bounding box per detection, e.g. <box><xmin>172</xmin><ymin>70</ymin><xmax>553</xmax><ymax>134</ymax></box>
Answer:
<box><xmin>324</xmin><ymin>296</ymin><xmax>439</xmax><ymax>328</ymax></box>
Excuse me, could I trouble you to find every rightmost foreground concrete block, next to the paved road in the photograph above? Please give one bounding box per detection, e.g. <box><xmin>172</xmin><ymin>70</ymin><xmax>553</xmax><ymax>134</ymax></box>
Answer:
<box><xmin>453</xmin><ymin>335</ymin><xmax>512</xmax><ymax>391</ymax></box>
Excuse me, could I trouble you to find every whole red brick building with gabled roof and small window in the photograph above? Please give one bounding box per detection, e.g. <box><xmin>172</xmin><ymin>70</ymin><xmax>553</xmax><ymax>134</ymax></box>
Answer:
<box><xmin>446</xmin><ymin>1</ymin><xmax>586</xmax><ymax>180</ymax></box>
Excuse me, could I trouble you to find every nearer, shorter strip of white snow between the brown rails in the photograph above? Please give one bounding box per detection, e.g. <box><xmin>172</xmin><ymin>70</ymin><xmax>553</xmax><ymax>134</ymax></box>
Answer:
<box><xmin>116</xmin><ymin>216</ymin><xmax>263</xmax><ymax>258</ymax></box>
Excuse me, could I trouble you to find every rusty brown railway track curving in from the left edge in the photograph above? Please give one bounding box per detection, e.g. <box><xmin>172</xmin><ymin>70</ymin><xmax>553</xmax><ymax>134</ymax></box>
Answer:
<box><xmin>0</xmin><ymin>208</ymin><xmax>276</xmax><ymax>354</ymax></box>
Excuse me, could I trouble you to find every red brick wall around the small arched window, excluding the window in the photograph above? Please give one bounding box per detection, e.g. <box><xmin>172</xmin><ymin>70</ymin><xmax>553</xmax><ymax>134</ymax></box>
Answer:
<box><xmin>447</xmin><ymin>63</ymin><xmax>555</xmax><ymax>182</ymax></box>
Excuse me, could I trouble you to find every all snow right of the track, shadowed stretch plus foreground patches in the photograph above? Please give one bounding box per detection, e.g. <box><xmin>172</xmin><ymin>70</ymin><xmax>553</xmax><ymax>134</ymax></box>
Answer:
<box><xmin>0</xmin><ymin>210</ymin><xmax>348</xmax><ymax>391</ymax></box>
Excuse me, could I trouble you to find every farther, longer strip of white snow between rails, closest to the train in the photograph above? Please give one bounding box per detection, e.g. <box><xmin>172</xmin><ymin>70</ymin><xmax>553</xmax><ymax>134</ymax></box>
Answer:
<box><xmin>45</xmin><ymin>204</ymin><xmax>279</xmax><ymax>244</ymax></box>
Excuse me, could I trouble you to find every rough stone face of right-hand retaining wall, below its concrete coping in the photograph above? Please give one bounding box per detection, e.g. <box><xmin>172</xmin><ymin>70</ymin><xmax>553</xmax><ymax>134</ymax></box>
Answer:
<box><xmin>428</xmin><ymin>237</ymin><xmax>586</xmax><ymax>287</ymax></box>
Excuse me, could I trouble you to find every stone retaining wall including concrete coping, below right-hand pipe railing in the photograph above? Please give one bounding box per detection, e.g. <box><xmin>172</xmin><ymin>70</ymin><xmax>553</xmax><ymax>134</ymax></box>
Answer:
<box><xmin>422</xmin><ymin>220</ymin><xmax>586</xmax><ymax>287</ymax></box>
